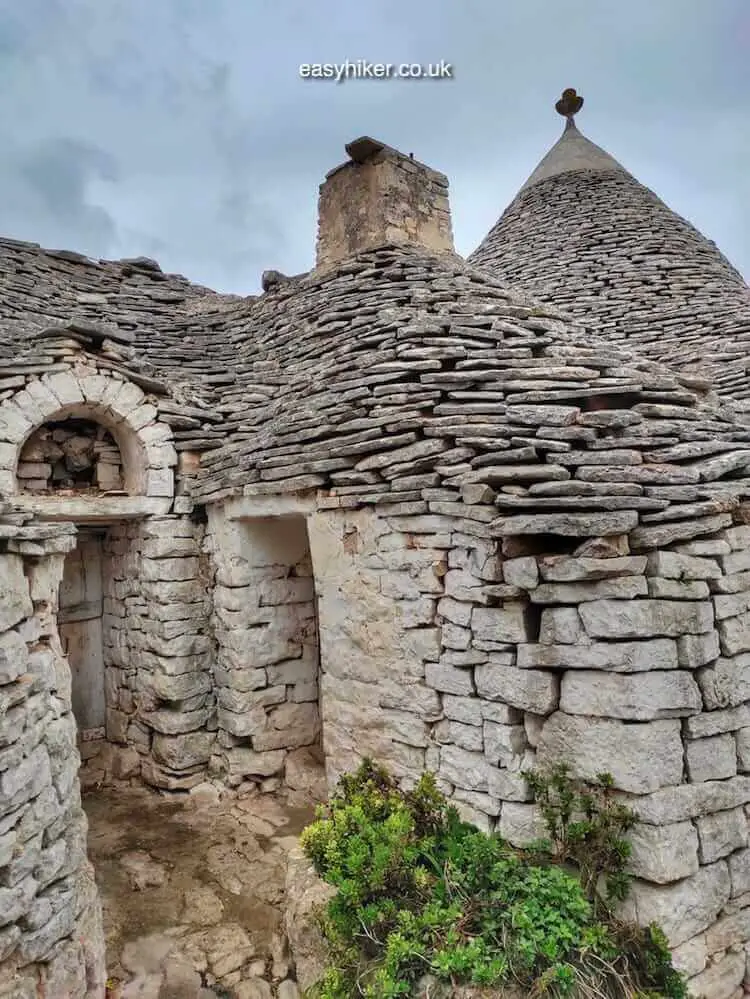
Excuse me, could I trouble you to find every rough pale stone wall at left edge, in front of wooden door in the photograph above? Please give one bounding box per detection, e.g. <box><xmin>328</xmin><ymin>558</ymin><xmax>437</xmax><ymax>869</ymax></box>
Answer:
<box><xmin>0</xmin><ymin>518</ymin><xmax>105</xmax><ymax>999</ymax></box>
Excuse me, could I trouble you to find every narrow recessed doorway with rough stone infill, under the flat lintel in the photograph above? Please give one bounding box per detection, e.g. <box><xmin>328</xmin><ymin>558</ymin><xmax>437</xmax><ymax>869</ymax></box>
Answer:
<box><xmin>208</xmin><ymin>507</ymin><xmax>320</xmax><ymax>789</ymax></box>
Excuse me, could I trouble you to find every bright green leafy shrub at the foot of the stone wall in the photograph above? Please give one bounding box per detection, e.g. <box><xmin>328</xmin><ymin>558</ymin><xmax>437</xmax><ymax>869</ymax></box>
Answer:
<box><xmin>302</xmin><ymin>761</ymin><xmax>686</xmax><ymax>999</ymax></box>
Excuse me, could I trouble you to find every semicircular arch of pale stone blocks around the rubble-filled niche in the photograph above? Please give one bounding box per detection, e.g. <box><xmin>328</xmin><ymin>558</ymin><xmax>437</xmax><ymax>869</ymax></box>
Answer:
<box><xmin>0</xmin><ymin>370</ymin><xmax>177</xmax><ymax>499</ymax></box>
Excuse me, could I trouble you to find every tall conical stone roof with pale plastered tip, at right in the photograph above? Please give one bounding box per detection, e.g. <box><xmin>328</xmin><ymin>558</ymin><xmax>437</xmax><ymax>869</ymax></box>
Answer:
<box><xmin>469</xmin><ymin>91</ymin><xmax>750</xmax><ymax>407</ymax></box>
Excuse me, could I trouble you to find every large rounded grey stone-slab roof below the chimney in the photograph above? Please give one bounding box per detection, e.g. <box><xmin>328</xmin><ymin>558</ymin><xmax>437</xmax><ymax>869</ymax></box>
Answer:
<box><xmin>191</xmin><ymin>247</ymin><xmax>750</xmax><ymax>547</ymax></box>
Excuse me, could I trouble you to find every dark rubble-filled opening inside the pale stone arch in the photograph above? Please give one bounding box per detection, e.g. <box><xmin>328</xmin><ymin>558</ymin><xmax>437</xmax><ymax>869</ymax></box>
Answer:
<box><xmin>17</xmin><ymin>419</ymin><xmax>124</xmax><ymax>493</ymax></box>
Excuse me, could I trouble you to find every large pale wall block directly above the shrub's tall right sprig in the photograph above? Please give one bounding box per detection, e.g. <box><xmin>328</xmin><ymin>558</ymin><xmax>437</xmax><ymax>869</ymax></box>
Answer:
<box><xmin>537</xmin><ymin>711</ymin><xmax>683</xmax><ymax>794</ymax></box>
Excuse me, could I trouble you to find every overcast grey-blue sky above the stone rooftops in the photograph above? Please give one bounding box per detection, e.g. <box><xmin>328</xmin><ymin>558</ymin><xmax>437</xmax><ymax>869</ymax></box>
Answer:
<box><xmin>0</xmin><ymin>0</ymin><xmax>750</xmax><ymax>293</ymax></box>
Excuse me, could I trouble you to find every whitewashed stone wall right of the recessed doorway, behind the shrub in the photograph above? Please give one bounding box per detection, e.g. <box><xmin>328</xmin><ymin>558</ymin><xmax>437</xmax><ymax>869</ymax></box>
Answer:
<box><xmin>309</xmin><ymin>510</ymin><xmax>750</xmax><ymax>999</ymax></box>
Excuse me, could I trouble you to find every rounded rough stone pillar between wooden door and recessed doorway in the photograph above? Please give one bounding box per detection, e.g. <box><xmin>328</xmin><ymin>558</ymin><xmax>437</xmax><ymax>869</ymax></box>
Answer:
<box><xmin>104</xmin><ymin>515</ymin><xmax>216</xmax><ymax>790</ymax></box>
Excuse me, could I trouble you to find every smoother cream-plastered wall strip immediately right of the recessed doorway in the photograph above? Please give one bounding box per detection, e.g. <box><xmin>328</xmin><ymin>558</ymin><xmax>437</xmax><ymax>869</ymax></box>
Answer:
<box><xmin>309</xmin><ymin>510</ymin><xmax>451</xmax><ymax>784</ymax></box>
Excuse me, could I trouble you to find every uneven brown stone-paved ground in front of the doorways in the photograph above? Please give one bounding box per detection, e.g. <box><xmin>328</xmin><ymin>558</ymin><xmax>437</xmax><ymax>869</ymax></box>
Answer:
<box><xmin>84</xmin><ymin>768</ymin><xmax>326</xmax><ymax>999</ymax></box>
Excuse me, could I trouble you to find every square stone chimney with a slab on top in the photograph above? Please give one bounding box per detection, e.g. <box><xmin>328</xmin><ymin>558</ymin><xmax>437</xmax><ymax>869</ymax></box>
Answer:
<box><xmin>316</xmin><ymin>137</ymin><xmax>455</xmax><ymax>269</ymax></box>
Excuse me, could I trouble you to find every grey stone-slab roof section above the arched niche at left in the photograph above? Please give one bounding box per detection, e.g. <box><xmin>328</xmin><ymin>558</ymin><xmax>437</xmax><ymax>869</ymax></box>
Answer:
<box><xmin>0</xmin><ymin>239</ymin><xmax>253</xmax><ymax>450</ymax></box>
